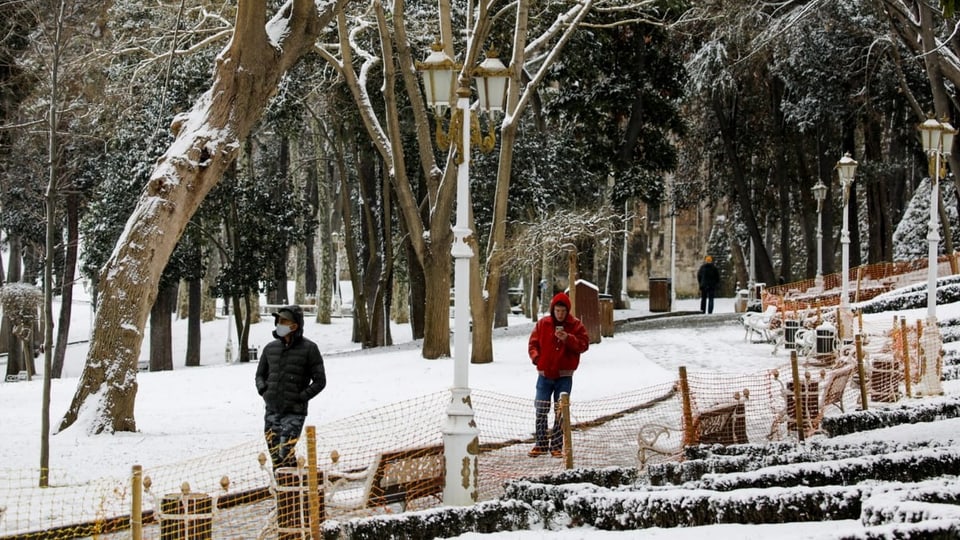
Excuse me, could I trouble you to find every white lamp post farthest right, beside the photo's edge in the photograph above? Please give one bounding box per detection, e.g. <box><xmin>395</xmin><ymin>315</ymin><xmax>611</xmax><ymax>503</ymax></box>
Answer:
<box><xmin>919</xmin><ymin>118</ymin><xmax>957</xmax><ymax>323</ymax></box>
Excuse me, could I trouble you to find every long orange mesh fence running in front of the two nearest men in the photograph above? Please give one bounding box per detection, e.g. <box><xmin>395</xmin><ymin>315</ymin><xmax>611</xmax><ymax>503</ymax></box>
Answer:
<box><xmin>0</xmin><ymin>322</ymin><xmax>928</xmax><ymax>539</ymax></box>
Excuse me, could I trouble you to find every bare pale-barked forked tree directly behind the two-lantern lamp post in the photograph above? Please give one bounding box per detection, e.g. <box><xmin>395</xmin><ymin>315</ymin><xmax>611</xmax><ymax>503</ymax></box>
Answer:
<box><xmin>321</xmin><ymin>0</ymin><xmax>655</xmax><ymax>363</ymax></box>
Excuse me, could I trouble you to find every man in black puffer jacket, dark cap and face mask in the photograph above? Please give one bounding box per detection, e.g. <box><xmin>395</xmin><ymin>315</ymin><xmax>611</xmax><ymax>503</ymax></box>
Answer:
<box><xmin>256</xmin><ymin>305</ymin><xmax>327</xmax><ymax>469</ymax></box>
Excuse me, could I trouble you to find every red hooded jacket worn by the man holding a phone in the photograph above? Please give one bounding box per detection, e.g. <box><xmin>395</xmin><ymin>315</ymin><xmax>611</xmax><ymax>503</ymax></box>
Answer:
<box><xmin>528</xmin><ymin>292</ymin><xmax>590</xmax><ymax>379</ymax></box>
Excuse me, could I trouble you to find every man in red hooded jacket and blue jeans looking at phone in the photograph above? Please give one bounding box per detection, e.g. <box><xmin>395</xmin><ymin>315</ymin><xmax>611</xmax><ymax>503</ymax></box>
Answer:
<box><xmin>528</xmin><ymin>292</ymin><xmax>590</xmax><ymax>457</ymax></box>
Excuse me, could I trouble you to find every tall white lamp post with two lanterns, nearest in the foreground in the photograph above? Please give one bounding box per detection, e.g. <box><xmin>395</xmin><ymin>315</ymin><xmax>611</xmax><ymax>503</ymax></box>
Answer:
<box><xmin>417</xmin><ymin>31</ymin><xmax>508</xmax><ymax>506</ymax></box>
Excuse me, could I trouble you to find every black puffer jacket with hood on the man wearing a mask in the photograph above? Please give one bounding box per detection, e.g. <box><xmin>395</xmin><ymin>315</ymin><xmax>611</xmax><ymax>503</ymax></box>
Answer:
<box><xmin>256</xmin><ymin>305</ymin><xmax>327</xmax><ymax>415</ymax></box>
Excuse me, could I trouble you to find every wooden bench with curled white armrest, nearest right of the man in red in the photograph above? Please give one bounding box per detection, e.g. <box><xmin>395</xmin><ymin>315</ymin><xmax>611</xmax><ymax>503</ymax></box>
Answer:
<box><xmin>637</xmin><ymin>389</ymin><xmax>750</xmax><ymax>467</ymax></box>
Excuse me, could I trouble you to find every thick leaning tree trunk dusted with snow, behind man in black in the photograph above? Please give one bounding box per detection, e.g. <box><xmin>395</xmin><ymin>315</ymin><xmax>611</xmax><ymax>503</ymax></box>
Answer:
<box><xmin>60</xmin><ymin>0</ymin><xmax>348</xmax><ymax>433</ymax></box>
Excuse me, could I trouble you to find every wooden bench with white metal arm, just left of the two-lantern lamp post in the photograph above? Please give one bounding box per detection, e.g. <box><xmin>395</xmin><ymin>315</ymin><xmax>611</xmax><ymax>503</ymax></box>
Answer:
<box><xmin>323</xmin><ymin>445</ymin><xmax>446</xmax><ymax>513</ymax></box>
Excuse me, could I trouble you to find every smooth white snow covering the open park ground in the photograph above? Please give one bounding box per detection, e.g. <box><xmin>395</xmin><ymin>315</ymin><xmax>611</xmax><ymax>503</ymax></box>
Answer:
<box><xmin>0</xmin><ymin>282</ymin><xmax>960</xmax><ymax>540</ymax></box>
